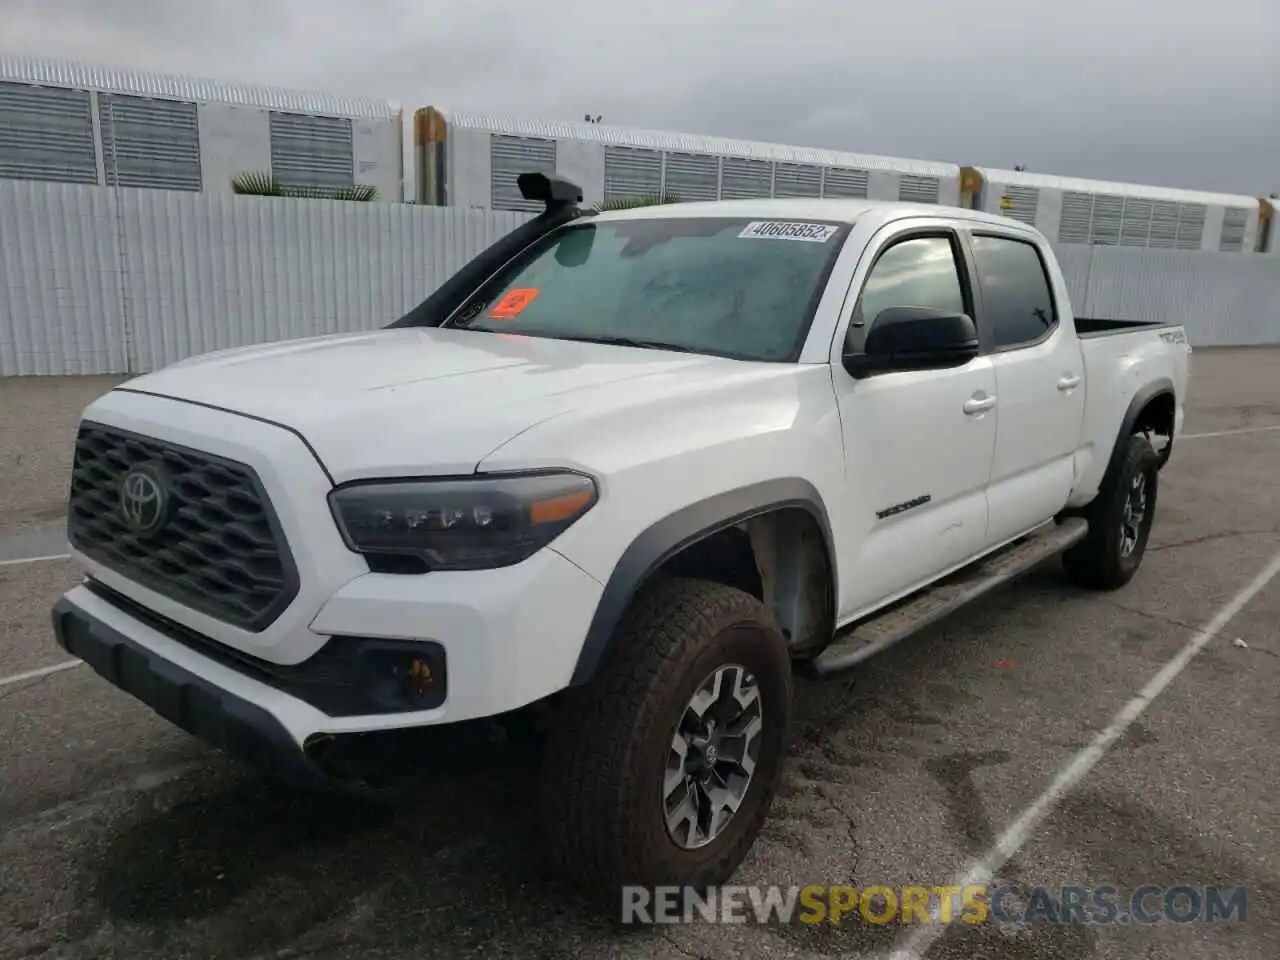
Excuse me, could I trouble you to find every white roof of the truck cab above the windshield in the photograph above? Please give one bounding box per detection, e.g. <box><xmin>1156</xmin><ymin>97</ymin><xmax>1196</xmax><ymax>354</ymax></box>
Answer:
<box><xmin>593</xmin><ymin>197</ymin><xmax>1030</xmax><ymax>229</ymax></box>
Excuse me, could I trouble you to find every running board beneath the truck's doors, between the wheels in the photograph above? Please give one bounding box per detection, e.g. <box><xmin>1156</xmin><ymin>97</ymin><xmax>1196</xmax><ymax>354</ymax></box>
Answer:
<box><xmin>796</xmin><ymin>517</ymin><xmax>1088</xmax><ymax>680</ymax></box>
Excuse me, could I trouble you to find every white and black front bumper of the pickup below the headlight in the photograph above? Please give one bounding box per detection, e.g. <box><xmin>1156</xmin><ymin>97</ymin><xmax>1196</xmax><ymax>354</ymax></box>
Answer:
<box><xmin>54</xmin><ymin>549</ymin><xmax>602</xmax><ymax>771</ymax></box>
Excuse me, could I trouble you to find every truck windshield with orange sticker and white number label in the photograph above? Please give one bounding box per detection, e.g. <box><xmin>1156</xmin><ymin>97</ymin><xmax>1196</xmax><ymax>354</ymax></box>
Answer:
<box><xmin>445</xmin><ymin>218</ymin><xmax>849</xmax><ymax>361</ymax></box>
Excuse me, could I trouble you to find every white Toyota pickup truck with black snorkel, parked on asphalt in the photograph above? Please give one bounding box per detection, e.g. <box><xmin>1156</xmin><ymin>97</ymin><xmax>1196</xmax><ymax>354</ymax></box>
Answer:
<box><xmin>54</xmin><ymin>174</ymin><xmax>1190</xmax><ymax>911</ymax></box>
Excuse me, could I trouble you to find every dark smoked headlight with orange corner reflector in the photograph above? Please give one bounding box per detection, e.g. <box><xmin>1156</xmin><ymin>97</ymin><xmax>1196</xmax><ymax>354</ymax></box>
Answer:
<box><xmin>329</xmin><ymin>472</ymin><xmax>596</xmax><ymax>570</ymax></box>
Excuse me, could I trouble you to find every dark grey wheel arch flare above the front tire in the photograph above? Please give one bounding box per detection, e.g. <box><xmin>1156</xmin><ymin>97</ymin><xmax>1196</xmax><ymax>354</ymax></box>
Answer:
<box><xmin>570</xmin><ymin>477</ymin><xmax>840</xmax><ymax>686</ymax></box>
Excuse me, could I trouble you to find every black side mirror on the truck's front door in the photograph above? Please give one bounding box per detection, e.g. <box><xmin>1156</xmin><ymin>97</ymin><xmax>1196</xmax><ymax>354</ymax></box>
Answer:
<box><xmin>844</xmin><ymin>307</ymin><xmax>979</xmax><ymax>378</ymax></box>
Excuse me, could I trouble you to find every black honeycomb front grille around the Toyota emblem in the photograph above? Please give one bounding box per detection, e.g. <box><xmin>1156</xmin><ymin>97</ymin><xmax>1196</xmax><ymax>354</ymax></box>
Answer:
<box><xmin>68</xmin><ymin>421</ymin><xmax>298</xmax><ymax>632</ymax></box>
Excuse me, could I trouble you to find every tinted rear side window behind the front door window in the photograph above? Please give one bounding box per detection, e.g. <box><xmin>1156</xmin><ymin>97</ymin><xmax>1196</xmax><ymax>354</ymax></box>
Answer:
<box><xmin>973</xmin><ymin>236</ymin><xmax>1057</xmax><ymax>349</ymax></box>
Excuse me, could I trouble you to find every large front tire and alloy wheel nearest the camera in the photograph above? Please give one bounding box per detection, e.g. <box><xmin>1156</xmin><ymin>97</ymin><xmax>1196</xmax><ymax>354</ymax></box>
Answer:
<box><xmin>541</xmin><ymin>579</ymin><xmax>791</xmax><ymax>906</ymax></box>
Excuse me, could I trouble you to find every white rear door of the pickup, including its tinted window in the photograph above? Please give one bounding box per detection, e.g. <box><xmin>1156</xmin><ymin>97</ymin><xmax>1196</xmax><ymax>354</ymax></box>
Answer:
<box><xmin>969</xmin><ymin>229</ymin><xmax>1085</xmax><ymax>545</ymax></box>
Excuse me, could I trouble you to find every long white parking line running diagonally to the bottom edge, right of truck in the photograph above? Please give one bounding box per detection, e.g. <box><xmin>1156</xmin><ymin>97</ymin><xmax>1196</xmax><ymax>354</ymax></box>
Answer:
<box><xmin>890</xmin><ymin>553</ymin><xmax>1280</xmax><ymax>960</ymax></box>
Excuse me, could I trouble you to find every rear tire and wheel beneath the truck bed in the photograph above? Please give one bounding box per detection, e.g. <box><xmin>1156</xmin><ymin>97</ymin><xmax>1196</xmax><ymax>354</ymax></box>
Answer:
<box><xmin>1062</xmin><ymin>435</ymin><xmax>1160</xmax><ymax>590</ymax></box>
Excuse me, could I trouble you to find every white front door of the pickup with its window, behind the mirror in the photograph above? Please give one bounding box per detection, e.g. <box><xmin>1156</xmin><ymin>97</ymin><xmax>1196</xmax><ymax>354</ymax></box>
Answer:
<box><xmin>832</xmin><ymin>228</ymin><xmax>997</xmax><ymax>621</ymax></box>
